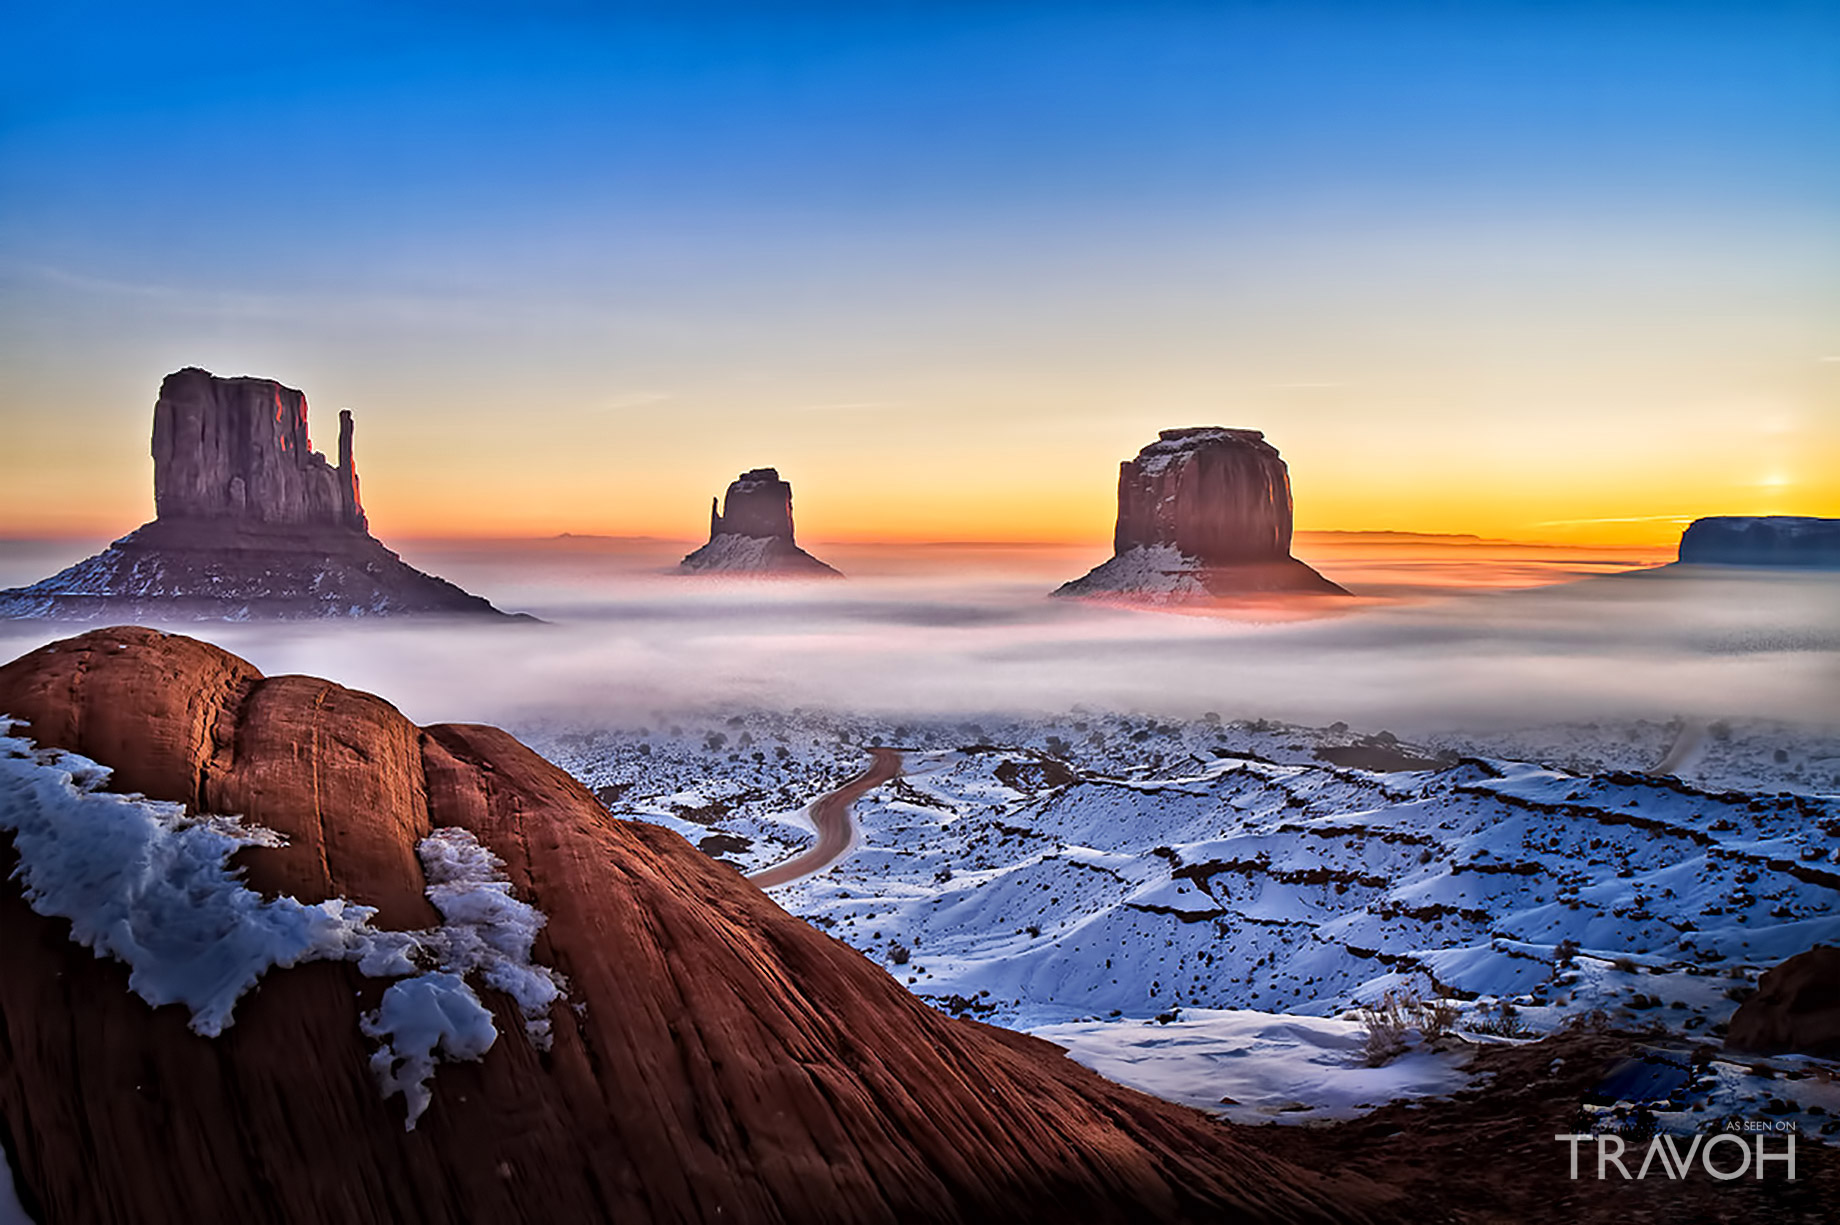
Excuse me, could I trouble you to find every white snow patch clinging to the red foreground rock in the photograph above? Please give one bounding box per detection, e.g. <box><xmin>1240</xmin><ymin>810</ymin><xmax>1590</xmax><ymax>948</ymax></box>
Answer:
<box><xmin>0</xmin><ymin>719</ymin><xmax>565</xmax><ymax>1129</ymax></box>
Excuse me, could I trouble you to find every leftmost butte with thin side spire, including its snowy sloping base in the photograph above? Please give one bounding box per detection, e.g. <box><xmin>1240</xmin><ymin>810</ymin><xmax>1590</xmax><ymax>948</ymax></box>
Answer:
<box><xmin>0</xmin><ymin>366</ymin><xmax>522</xmax><ymax>622</ymax></box>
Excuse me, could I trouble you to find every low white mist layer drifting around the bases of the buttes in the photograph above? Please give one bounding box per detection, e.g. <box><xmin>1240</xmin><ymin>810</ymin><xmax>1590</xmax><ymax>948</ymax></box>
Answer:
<box><xmin>0</xmin><ymin>537</ymin><xmax>1840</xmax><ymax>734</ymax></box>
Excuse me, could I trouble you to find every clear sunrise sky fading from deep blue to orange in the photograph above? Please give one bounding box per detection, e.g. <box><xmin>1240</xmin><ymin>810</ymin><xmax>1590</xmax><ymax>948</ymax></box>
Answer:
<box><xmin>0</xmin><ymin>0</ymin><xmax>1840</xmax><ymax>544</ymax></box>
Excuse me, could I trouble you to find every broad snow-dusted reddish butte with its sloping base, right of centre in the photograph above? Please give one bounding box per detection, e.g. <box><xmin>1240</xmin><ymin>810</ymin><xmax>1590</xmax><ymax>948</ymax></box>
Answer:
<box><xmin>1054</xmin><ymin>425</ymin><xmax>1349</xmax><ymax>603</ymax></box>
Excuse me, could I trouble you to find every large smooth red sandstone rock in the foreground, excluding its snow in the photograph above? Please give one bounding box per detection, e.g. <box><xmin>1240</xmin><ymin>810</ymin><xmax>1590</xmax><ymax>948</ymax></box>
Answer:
<box><xmin>0</xmin><ymin>629</ymin><xmax>1402</xmax><ymax>1225</ymax></box>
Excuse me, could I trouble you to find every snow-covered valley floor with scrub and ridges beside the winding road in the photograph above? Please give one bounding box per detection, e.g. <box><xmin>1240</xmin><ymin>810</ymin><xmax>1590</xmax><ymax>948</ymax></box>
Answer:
<box><xmin>521</xmin><ymin>712</ymin><xmax>1840</xmax><ymax>1137</ymax></box>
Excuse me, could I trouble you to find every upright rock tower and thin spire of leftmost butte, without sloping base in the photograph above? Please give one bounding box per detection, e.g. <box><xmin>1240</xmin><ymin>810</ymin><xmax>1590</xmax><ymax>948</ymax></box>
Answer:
<box><xmin>153</xmin><ymin>366</ymin><xmax>368</xmax><ymax>532</ymax></box>
